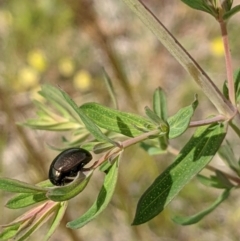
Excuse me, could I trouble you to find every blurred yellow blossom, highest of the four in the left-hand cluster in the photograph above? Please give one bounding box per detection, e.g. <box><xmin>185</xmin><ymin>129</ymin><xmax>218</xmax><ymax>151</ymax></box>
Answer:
<box><xmin>27</xmin><ymin>49</ymin><xmax>47</xmax><ymax>72</ymax></box>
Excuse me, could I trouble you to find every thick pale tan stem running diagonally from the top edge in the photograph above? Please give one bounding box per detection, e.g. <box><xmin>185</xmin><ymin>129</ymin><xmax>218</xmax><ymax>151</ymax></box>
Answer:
<box><xmin>123</xmin><ymin>0</ymin><xmax>235</xmax><ymax>118</ymax></box>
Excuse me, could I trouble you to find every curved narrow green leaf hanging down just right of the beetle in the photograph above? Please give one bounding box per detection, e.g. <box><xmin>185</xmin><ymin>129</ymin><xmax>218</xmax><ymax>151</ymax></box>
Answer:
<box><xmin>67</xmin><ymin>159</ymin><xmax>118</xmax><ymax>229</ymax></box>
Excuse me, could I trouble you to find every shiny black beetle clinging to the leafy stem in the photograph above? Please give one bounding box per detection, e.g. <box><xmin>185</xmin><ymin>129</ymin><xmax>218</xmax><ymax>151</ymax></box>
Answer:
<box><xmin>49</xmin><ymin>148</ymin><xmax>92</xmax><ymax>186</ymax></box>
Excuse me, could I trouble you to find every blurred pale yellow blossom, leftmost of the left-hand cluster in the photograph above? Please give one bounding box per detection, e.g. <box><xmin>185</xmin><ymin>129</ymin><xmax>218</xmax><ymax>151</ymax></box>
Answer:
<box><xmin>14</xmin><ymin>67</ymin><xmax>39</xmax><ymax>91</ymax></box>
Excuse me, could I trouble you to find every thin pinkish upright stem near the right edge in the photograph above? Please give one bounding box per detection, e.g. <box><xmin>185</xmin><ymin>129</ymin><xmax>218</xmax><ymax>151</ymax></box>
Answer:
<box><xmin>219</xmin><ymin>20</ymin><xmax>236</xmax><ymax>105</ymax></box>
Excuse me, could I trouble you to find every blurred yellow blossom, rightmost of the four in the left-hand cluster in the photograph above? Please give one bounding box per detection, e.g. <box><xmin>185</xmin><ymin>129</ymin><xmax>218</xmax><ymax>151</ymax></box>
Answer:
<box><xmin>73</xmin><ymin>70</ymin><xmax>92</xmax><ymax>91</ymax></box>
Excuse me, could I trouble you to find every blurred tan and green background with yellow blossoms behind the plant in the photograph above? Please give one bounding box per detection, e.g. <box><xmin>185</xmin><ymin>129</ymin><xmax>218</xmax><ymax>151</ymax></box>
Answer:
<box><xmin>0</xmin><ymin>0</ymin><xmax>240</xmax><ymax>241</ymax></box>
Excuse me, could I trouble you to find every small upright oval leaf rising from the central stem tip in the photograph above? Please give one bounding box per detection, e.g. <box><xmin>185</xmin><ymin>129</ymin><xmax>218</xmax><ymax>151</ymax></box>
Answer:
<box><xmin>153</xmin><ymin>87</ymin><xmax>168</xmax><ymax>121</ymax></box>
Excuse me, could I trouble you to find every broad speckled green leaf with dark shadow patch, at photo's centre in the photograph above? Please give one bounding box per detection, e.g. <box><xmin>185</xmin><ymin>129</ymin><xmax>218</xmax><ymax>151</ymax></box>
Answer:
<box><xmin>80</xmin><ymin>103</ymin><xmax>156</xmax><ymax>137</ymax></box>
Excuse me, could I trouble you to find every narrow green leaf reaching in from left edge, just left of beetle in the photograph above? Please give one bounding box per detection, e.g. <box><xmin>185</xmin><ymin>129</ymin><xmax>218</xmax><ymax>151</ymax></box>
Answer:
<box><xmin>0</xmin><ymin>178</ymin><xmax>47</xmax><ymax>193</ymax></box>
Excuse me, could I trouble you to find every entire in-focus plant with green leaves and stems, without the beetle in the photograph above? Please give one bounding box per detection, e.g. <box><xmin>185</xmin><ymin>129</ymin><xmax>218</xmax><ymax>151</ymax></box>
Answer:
<box><xmin>0</xmin><ymin>0</ymin><xmax>240</xmax><ymax>240</ymax></box>
